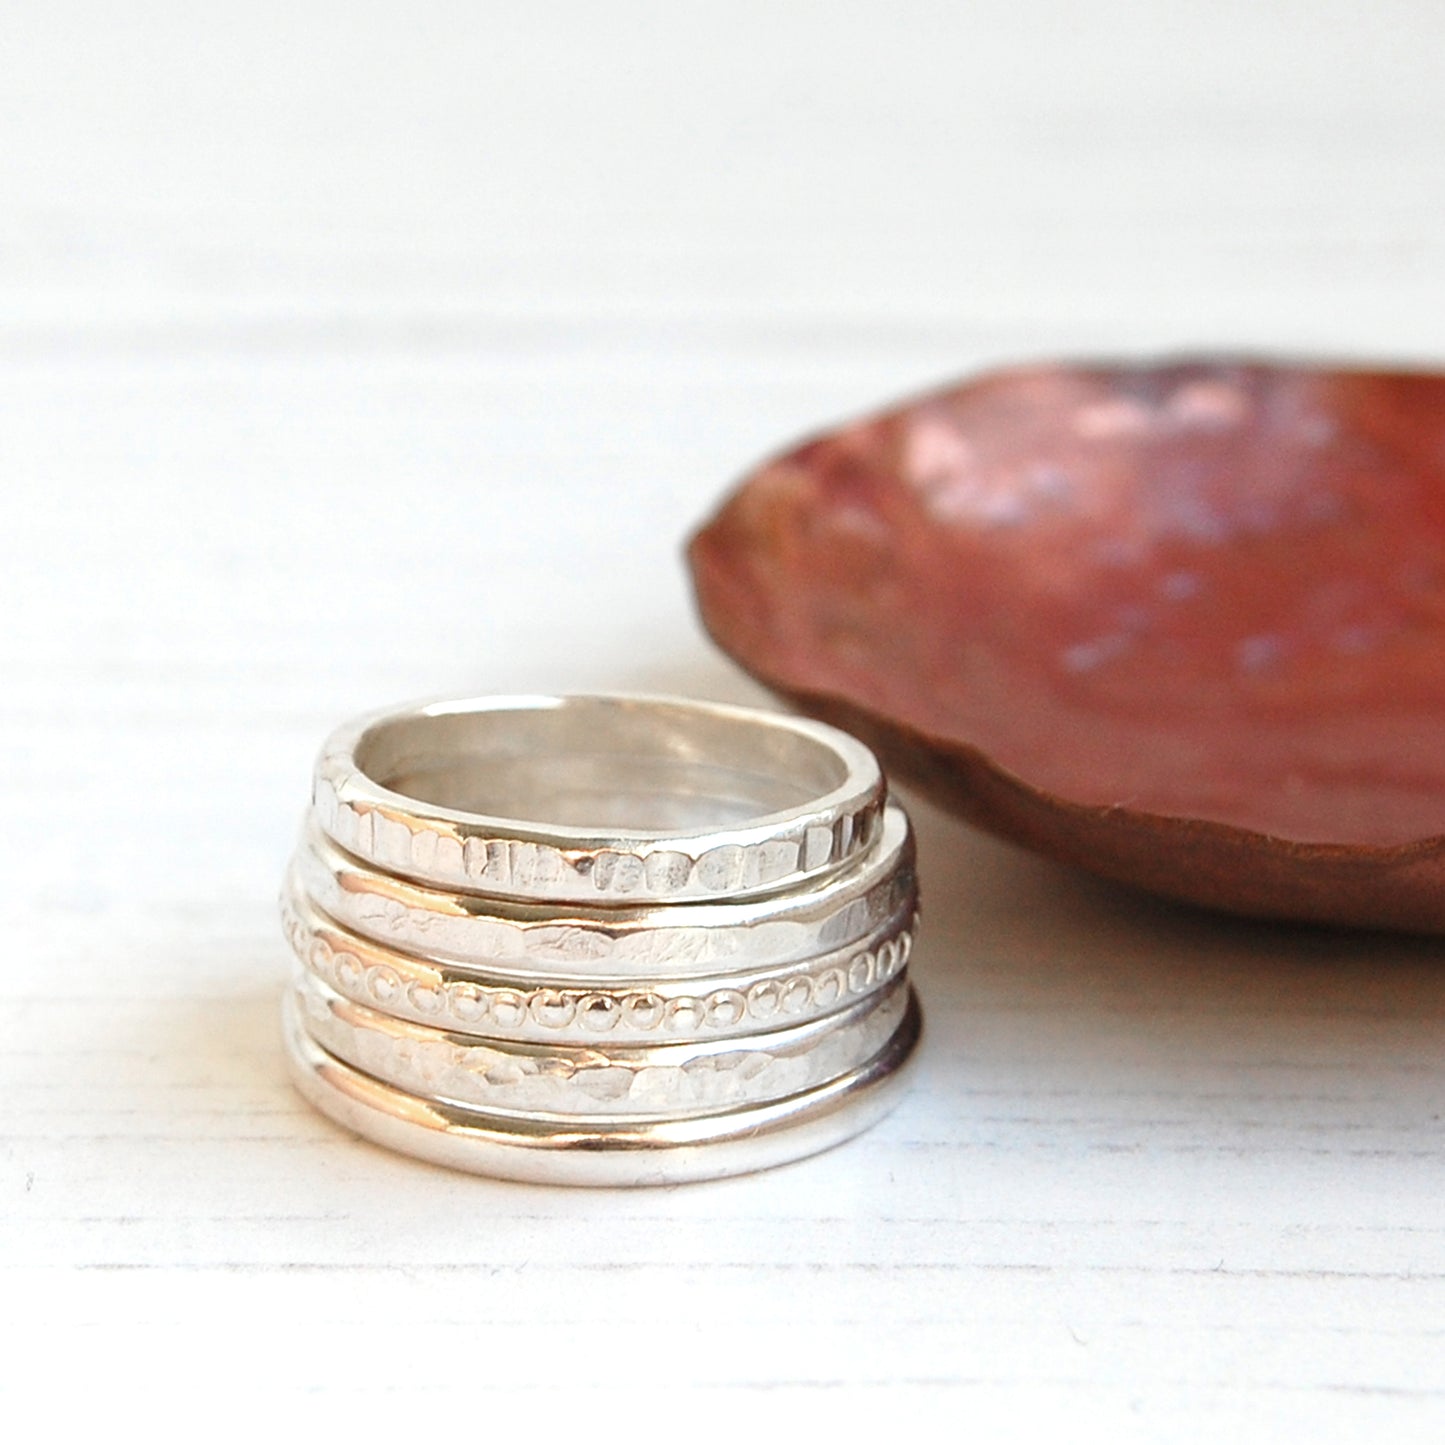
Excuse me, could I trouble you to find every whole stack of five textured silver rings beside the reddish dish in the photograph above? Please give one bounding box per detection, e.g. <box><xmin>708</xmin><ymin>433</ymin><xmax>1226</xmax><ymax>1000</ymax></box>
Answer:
<box><xmin>282</xmin><ymin>696</ymin><xmax>920</xmax><ymax>1185</ymax></box>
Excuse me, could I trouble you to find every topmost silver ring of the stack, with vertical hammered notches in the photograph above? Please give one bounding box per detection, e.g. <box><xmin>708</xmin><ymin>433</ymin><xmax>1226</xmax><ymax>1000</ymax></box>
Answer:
<box><xmin>314</xmin><ymin>696</ymin><xmax>884</xmax><ymax>903</ymax></box>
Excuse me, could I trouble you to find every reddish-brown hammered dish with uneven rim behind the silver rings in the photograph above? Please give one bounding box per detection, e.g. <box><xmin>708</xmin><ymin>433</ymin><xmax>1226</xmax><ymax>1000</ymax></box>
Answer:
<box><xmin>689</xmin><ymin>361</ymin><xmax>1445</xmax><ymax>932</ymax></box>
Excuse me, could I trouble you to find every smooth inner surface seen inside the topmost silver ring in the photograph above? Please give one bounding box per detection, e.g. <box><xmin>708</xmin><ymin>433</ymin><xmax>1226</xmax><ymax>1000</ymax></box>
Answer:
<box><xmin>355</xmin><ymin>699</ymin><xmax>848</xmax><ymax>832</ymax></box>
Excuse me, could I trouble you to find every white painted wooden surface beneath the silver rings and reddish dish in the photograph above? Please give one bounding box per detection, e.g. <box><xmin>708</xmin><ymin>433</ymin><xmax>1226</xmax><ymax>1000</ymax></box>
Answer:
<box><xmin>0</xmin><ymin>0</ymin><xmax>1445</xmax><ymax>1441</ymax></box>
